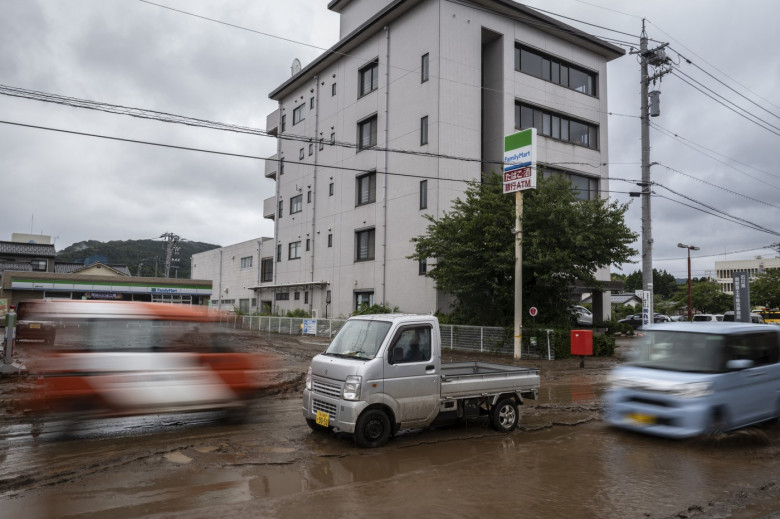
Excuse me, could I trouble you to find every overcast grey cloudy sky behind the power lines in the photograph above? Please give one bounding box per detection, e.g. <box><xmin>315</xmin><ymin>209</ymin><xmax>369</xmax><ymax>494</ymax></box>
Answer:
<box><xmin>0</xmin><ymin>0</ymin><xmax>780</xmax><ymax>277</ymax></box>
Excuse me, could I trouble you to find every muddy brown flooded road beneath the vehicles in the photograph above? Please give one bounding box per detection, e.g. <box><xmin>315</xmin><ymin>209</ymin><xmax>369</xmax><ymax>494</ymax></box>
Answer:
<box><xmin>0</xmin><ymin>330</ymin><xmax>780</xmax><ymax>519</ymax></box>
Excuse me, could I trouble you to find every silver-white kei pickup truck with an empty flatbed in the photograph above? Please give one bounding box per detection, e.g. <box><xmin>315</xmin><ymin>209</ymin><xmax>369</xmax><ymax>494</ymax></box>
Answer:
<box><xmin>303</xmin><ymin>314</ymin><xmax>539</xmax><ymax>448</ymax></box>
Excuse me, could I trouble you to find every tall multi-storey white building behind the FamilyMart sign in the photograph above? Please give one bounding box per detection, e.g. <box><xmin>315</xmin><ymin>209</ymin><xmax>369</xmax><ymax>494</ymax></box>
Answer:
<box><xmin>259</xmin><ymin>0</ymin><xmax>624</xmax><ymax>317</ymax></box>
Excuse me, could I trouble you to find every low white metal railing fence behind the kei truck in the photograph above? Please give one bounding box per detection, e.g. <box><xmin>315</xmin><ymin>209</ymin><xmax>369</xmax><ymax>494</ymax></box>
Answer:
<box><xmin>223</xmin><ymin>315</ymin><xmax>555</xmax><ymax>360</ymax></box>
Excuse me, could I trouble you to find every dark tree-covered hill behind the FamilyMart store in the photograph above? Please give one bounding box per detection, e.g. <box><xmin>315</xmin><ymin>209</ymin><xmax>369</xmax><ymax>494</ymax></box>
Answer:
<box><xmin>57</xmin><ymin>240</ymin><xmax>220</xmax><ymax>279</ymax></box>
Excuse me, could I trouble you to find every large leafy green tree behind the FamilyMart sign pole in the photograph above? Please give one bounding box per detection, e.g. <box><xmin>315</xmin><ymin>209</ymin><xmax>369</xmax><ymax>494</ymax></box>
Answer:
<box><xmin>411</xmin><ymin>174</ymin><xmax>637</xmax><ymax>326</ymax></box>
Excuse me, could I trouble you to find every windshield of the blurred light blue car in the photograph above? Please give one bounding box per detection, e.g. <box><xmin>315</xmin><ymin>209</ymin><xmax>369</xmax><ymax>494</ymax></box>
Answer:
<box><xmin>631</xmin><ymin>330</ymin><xmax>725</xmax><ymax>373</ymax></box>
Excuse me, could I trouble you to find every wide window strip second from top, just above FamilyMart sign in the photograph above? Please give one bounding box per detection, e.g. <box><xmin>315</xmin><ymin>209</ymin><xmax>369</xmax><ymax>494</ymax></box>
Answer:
<box><xmin>515</xmin><ymin>102</ymin><xmax>599</xmax><ymax>150</ymax></box>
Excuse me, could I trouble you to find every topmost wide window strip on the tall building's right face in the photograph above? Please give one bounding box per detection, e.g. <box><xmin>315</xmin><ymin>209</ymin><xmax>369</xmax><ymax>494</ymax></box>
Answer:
<box><xmin>515</xmin><ymin>43</ymin><xmax>598</xmax><ymax>97</ymax></box>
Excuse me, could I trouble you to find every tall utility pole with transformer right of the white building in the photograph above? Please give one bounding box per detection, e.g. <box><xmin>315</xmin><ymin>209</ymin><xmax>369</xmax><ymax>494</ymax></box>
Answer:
<box><xmin>632</xmin><ymin>19</ymin><xmax>671</xmax><ymax>325</ymax></box>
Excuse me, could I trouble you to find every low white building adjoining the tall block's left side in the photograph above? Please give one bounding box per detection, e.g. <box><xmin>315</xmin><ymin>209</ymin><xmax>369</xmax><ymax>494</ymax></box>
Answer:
<box><xmin>191</xmin><ymin>238</ymin><xmax>274</xmax><ymax>313</ymax></box>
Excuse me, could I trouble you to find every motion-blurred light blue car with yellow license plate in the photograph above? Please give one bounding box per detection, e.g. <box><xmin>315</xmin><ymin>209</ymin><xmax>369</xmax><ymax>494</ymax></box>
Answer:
<box><xmin>604</xmin><ymin>322</ymin><xmax>780</xmax><ymax>438</ymax></box>
